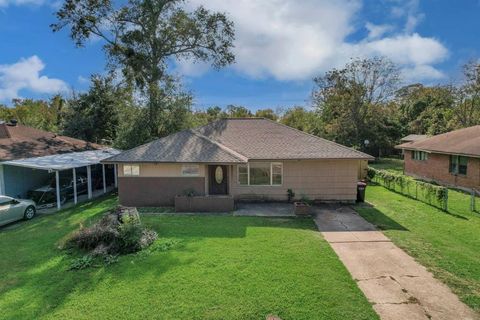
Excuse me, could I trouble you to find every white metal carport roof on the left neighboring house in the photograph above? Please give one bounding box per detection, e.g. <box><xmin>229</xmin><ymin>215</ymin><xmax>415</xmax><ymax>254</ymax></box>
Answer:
<box><xmin>0</xmin><ymin>148</ymin><xmax>120</xmax><ymax>171</ymax></box>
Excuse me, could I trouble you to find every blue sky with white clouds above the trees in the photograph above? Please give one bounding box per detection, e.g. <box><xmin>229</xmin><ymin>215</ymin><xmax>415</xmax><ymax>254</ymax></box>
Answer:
<box><xmin>0</xmin><ymin>0</ymin><xmax>480</xmax><ymax>110</ymax></box>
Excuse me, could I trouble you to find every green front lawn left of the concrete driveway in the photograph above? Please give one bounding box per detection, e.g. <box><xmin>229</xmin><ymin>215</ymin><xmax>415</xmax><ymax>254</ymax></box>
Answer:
<box><xmin>0</xmin><ymin>197</ymin><xmax>378</xmax><ymax>320</ymax></box>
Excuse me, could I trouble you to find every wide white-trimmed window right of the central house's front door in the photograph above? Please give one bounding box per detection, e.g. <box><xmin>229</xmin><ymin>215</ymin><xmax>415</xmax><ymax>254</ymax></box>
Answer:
<box><xmin>237</xmin><ymin>162</ymin><xmax>283</xmax><ymax>186</ymax></box>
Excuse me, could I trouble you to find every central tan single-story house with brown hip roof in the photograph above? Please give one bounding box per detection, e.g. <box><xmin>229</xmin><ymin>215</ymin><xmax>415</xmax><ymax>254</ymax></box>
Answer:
<box><xmin>102</xmin><ymin>118</ymin><xmax>373</xmax><ymax>211</ymax></box>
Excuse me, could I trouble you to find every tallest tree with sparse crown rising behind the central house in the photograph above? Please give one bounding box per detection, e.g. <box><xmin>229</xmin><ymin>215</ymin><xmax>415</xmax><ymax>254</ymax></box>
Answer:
<box><xmin>52</xmin><ymin>0</ymin><xmax>234</xmax><ymax>140</ymax></box>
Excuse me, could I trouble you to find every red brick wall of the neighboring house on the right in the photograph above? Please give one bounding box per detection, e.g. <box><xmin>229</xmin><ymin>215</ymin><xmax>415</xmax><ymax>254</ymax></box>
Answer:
<box><xmin>405</xmin><ymin>150</ymin><xmax>480</xmax><ymax>188</ymax></box>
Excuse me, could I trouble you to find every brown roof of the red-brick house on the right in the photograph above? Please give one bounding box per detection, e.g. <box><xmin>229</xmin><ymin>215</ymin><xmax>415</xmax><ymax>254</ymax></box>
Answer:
<box><xmin>396</xmin><ymin>126</ymin><xmax>480</xmax><ymax>157</ymax></box>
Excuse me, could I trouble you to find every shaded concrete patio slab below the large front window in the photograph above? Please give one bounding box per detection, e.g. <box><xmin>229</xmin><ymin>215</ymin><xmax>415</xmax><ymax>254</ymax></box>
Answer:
<box><xmin>233</xmin><ymin>202</ymin><xmax>295</xmax><ymax>217</ymax></box>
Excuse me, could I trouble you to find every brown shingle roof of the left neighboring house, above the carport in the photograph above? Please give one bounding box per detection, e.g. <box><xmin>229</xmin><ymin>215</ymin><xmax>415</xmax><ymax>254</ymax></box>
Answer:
<box><xmin>0</xmin><ymin>123</ymin><xmax>101</xmax><ymax>161</ymax></box>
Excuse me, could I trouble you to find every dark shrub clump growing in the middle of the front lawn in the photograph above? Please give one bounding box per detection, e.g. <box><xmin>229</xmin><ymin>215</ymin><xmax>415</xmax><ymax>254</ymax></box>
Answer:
<box><xmin>65</xmin><ymin>206</ymin><xmax>158</xmax><ymax>269</ymax></box>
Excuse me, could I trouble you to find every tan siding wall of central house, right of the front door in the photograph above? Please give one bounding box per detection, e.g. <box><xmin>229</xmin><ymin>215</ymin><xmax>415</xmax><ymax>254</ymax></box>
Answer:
<box><xmin>230</xmin><ymin>160</ymin><xmax>361</xmax><ymax>202</ymax></box>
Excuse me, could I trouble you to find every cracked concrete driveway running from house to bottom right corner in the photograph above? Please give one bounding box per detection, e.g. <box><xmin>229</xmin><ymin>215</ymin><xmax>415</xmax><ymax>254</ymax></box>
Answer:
<box><xmin>315</xmin><ymin>206</ymin><xmax>479</xmax><ymax>320</ymax></box>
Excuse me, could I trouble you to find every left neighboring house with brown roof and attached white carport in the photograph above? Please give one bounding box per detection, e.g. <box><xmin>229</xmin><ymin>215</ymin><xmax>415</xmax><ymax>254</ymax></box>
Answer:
<box><xmin>0</xmin><ymin>120</ymin><xmax>118</xmax><ymax>207</ymax></box>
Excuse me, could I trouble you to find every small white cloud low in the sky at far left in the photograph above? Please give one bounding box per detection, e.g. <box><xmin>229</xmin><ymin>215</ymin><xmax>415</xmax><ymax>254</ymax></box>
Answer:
<box><xmin>0</xmin><ymin>56</ymin><xmax>68</xmax><ymax>101</ymax></box>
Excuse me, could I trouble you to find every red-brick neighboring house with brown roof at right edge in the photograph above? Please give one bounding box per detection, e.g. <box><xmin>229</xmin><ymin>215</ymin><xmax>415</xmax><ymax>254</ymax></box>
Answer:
<box><xmin>396</xmin><ymin>126</ymin><xmax>480</xmax><ymax>188</ymax></box>
